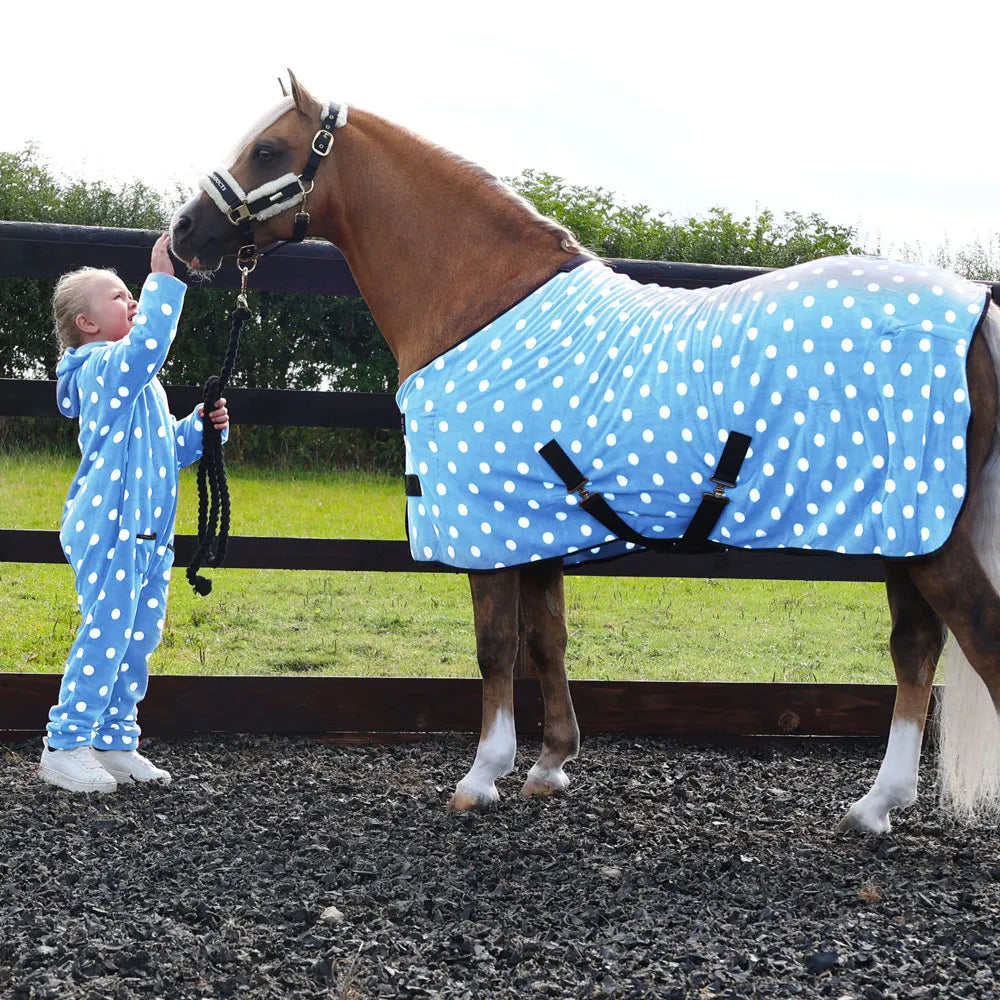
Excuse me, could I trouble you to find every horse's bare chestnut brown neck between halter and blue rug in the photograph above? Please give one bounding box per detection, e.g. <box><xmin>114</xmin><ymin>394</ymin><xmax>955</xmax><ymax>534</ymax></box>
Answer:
<box><xmin>324</xmin><ymin>110</ymin><xmax>578</xmax><ymax>379</ymax></box>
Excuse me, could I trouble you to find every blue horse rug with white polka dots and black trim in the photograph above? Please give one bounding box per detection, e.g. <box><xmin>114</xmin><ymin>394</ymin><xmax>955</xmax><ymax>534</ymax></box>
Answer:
<box><xmin>396</xmin><ymin>257</ymin><xmax>989</xmax><ymax>571</ymax></box>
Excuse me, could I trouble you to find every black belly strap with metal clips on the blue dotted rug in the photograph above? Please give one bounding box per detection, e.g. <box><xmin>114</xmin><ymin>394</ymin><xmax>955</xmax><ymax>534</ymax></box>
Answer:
<box><xmin>538</xmin><ymin>431</ymin><xmax>750</xmax><ymax>552</ymax></box>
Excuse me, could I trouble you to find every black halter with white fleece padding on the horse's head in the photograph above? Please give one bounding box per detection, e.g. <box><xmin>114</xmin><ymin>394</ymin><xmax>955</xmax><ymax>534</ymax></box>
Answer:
<box><xmin>199</xmin><ymin>104</ymin><xmax>347</xmax><ymax>270</ymax></box>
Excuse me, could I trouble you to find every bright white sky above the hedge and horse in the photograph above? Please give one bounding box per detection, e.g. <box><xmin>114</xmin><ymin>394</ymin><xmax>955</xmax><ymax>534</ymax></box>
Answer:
<box><xmin>0</xmin><ymin>0</ymin><xmax>1000</xmax><ymax>260</ymax></box>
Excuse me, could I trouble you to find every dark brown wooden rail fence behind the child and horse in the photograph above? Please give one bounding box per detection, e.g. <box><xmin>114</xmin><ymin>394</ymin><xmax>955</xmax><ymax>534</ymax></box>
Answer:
<box><xmin>0</xmin><ymin>222</ymin><xmax>894</xmax><ymax>739</ymax></box>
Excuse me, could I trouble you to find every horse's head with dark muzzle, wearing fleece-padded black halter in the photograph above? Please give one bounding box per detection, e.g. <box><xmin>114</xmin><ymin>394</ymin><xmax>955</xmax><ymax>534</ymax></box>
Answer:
<box><xmin>170</xmin><ymin>70</ymin><xmax>347</xmax><ymax>271</ymax></box>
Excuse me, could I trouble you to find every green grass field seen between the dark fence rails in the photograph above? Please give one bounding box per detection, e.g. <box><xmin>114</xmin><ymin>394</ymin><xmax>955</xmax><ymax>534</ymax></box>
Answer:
<box><xmin>0</xmin><ymin>454</ymin><xmax>892</xmax><ymax>683</ymax></box>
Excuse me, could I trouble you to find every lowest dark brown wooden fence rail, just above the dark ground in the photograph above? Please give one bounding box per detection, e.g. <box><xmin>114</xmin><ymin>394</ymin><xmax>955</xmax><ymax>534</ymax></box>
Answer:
<box><xmin>0</xmin><ymin>673</ymin><xmax>908</xmax><ymax>740</ymax></box>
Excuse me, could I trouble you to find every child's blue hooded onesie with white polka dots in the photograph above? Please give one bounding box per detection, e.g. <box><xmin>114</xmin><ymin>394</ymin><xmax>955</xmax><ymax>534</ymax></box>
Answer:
<box><xmin>47</xmin><ymin>274</ymin><xmax>209</xmax><ymax>750</ymax></box>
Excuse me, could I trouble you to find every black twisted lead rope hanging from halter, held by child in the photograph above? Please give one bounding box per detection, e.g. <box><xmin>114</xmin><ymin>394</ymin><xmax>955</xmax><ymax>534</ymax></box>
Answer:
<box><xmin>187</xmin><ymin>266</ymin><xmax>253</xmax><ymax>597</ymax></box>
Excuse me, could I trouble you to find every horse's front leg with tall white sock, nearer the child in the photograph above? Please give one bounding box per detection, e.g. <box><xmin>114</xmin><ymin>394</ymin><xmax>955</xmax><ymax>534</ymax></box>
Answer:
<box><xmin>448</xmin><ymin>569</ymin><xmax>520</xmax><ymax>812</ymax></box>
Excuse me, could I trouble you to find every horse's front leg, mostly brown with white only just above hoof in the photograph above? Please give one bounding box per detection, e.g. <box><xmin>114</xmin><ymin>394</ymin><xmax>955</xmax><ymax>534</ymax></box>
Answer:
<box><xmin>521</xmin><ymin>560</ymin><xmax>580</xmax><ymax>795</ymax></box>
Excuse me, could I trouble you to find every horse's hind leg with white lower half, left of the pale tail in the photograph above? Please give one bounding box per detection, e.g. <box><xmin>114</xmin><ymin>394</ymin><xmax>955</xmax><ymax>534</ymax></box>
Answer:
<box><xmin>839</xmin><ymin>563</ymin><xmax>945</xmax><ymax>834</ymax></box>
